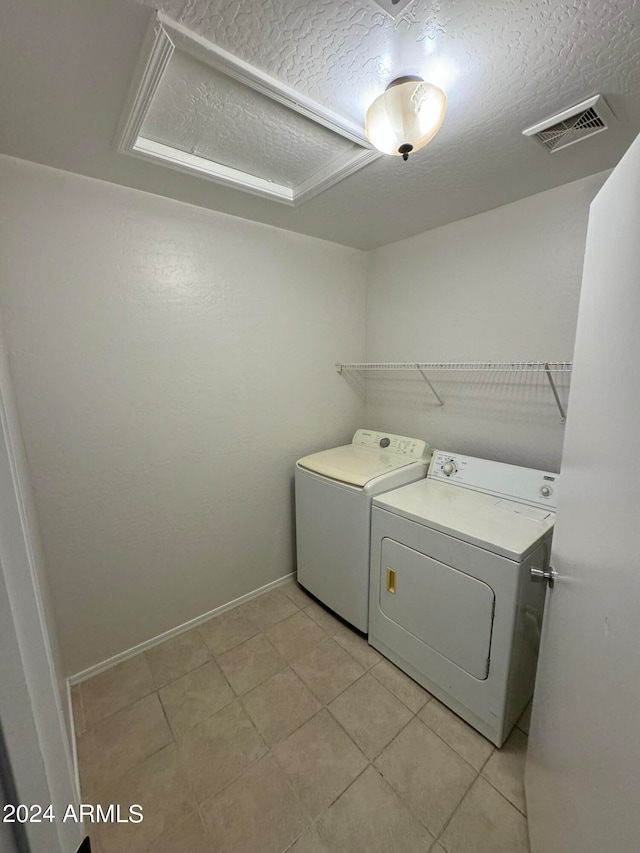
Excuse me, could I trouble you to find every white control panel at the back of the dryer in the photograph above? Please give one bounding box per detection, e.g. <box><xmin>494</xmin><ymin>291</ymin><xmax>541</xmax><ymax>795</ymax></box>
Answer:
<box><xmin>427</xmin><ymin>450</ymin><xmax>560</xmax><ymax>511</ymax></box>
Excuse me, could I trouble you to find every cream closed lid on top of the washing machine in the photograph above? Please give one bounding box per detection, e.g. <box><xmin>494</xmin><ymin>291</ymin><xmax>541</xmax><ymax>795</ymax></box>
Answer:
<box><xmin>298</xmin><ymin>444</ymin><xmax>416</xmax><ymax>487</ymax></box>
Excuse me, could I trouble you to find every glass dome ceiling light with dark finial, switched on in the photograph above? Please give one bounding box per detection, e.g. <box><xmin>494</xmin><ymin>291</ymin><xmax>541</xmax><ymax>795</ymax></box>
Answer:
<box><xmin>365</xmin><ymin>77</ymin><xmax>447</xmax><ymax>160</ymax></box>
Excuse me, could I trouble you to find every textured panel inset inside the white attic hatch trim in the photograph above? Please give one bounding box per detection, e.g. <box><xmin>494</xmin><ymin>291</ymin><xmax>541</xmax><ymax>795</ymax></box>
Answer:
<box><xmin>141</xmin><ymin>51</ymin><xmax>358</xmax><ymax>187</ymax></box>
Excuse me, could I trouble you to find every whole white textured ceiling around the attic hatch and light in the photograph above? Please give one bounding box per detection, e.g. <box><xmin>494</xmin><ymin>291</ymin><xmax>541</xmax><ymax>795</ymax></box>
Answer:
<box><xmin>0</xmin><ymin>0</ymin><xmax>640</xmax><ymax>248</ymax></box>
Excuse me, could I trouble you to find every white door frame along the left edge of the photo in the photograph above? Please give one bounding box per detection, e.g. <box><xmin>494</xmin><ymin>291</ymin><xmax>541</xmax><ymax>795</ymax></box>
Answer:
<box><xmin>0</xmin><ymin>325</ymin><xmax>84</xmax><ymax>853</ymax></box>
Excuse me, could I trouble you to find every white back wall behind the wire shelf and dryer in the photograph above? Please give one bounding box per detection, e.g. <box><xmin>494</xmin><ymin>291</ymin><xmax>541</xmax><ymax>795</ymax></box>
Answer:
<box><xmin>365</xmin><ymin>174</ymin><xmax>606</xmax><ymax>470</ymax></box>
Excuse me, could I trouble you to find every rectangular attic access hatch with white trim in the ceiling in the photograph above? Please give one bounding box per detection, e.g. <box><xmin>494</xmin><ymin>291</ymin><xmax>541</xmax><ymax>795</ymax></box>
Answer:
<box><xmin>117</xmin><ymin>13</ymin><xmax>380</xmax><ymax>205</ymax></box>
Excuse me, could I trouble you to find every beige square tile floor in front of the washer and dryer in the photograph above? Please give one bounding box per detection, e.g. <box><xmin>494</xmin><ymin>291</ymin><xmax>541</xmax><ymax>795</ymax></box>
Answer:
<box><xmin>72</xmin><ymin>583</ymin><xmax>529</xmax><ymax>853</ymax></box>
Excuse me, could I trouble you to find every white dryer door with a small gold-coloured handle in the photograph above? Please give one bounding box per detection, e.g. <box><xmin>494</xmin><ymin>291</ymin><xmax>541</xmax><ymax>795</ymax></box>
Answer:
<box><xmin>380</xmin><ymin>539</ymin><xmax>495</xmax><ymax>680</ymax></box>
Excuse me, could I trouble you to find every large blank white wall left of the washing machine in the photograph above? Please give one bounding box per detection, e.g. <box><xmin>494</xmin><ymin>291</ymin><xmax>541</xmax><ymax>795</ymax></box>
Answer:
<box><xmin>0</xmin><ymin>157</ymin><xmax>366</xmax><ymax>674</ymax></box>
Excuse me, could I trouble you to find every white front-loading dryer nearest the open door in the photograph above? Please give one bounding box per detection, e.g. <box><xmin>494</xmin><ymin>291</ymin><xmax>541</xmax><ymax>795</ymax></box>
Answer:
<box><xmin>369</xmin><ymin>451</ymin><xmax>559</xmax><ymax>746</ymax></box>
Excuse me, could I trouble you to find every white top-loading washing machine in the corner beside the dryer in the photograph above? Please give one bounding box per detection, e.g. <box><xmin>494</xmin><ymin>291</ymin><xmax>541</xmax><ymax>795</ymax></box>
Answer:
<box><xmin>295</xmin><ymin>429</ymin><xmax>431</xmax><ymax>632</ymax></box>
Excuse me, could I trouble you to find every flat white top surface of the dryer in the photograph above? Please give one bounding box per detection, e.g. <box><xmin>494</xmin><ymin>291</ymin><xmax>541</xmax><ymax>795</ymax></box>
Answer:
<box><xmin>373</xmin><ymin>480</ymin><xmax>556</xmax><ymax>562</ymax></box>
